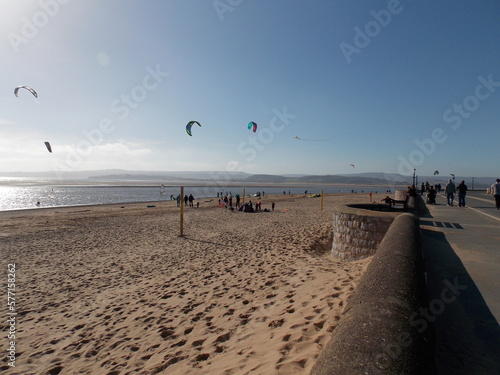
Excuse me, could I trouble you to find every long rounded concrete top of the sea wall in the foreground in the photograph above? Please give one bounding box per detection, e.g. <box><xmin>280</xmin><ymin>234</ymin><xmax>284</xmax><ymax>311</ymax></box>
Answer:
<box><xmin>311</xmin><ymin>213</ymin><xmax>435</xmax><ymax>375</ymax></box>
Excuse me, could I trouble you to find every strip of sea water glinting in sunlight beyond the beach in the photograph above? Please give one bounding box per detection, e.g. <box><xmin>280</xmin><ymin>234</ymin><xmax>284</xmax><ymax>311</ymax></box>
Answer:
<box><xmin>0</xmin><ymin>179</ymin><xmax>390</xmax><ymax>211</ymax></box>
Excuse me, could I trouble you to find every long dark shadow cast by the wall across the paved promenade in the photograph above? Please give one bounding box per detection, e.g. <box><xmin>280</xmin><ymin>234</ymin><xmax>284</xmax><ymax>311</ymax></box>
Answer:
<box><xmin>419</xmin><ymin>229</ymin><xmax>500</xmax><ymax>375</ymax></box>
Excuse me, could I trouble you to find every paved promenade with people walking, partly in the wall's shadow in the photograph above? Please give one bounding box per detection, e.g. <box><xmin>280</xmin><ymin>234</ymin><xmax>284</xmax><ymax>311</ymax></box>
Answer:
<box><xmin>415</xmin><ymin>192</ymin><xmax>500</xmax><ymax>375</ymax></box>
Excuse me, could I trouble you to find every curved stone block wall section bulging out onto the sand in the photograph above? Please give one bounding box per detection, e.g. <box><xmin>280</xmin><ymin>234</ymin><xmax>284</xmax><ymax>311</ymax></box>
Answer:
<box><xmin>331</xmin><ymin>204</ymin><xmax>401</xmax><ymax>260</ymax></box>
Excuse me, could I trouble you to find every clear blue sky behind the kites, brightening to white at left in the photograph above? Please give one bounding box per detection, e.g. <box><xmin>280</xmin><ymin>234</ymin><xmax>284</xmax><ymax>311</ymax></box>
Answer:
<box><xmin>0</xmin><ymin>0</ymin><xmax>500</xmax><ymax>177</ymax></box>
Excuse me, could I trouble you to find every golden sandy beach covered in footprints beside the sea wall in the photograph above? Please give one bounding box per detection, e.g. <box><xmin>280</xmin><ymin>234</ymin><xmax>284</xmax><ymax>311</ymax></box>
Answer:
<box><xmin>0</xmin><ymin>191</ymin><xmax>383</xmax><ymax>375</ymax></box>
